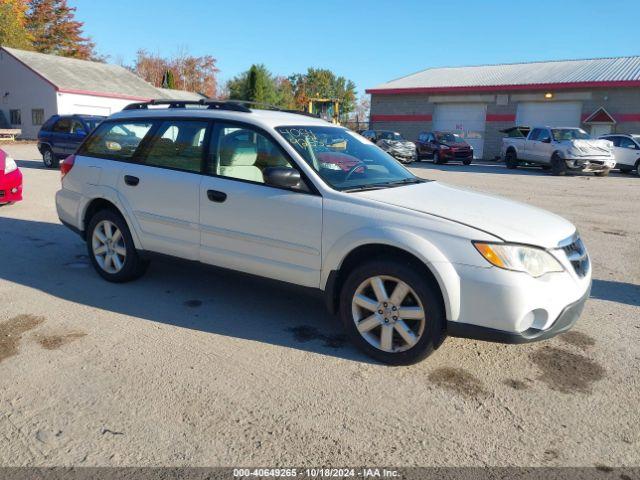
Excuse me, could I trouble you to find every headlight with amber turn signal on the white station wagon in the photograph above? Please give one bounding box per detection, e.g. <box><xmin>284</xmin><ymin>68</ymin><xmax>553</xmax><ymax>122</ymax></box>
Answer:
<box><xmin>473</xmin><ymin>242</ymin><xmax>564</xmax><ymax>277</ymax></box>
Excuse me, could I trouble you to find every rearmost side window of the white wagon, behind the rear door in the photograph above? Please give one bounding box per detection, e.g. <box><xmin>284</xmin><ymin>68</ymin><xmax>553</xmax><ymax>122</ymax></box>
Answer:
<box><xmin>79</xmin><ymin>121</ymin><xmax>153</xmax><ymax>160</ymax></box>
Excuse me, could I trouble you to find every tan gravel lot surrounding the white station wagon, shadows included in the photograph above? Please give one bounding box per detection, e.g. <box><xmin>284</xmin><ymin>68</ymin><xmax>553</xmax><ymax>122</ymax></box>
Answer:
<box><xmin>0</xmin><ymin>144</ymin><xmax>640</xmax><ymax>466</ymax></box>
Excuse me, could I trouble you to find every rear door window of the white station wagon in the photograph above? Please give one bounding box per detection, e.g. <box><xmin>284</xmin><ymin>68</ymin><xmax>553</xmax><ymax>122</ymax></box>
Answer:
<box><xmin>140</xmin><ymin>120</ymin><xmax>209</xmax><ymax>173</ymax></box>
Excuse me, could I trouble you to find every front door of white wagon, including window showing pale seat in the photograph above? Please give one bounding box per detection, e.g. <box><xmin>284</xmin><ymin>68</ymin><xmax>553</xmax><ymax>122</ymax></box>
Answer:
<box><xmin>200</xmin><ymin>122</ymin><xmax>322</xmax><ymax>288</ymax></box>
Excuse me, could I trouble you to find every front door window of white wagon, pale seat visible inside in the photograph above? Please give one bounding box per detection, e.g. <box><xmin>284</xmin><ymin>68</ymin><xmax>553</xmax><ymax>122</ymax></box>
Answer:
<box><xmin>207</xmin><ymin>123</ymin><xmax>294</xmax><ymax>183</ymax></box>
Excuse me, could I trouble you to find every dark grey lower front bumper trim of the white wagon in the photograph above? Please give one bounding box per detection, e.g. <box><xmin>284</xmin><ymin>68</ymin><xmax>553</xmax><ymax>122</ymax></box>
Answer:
<box><xmin>447</xmin><ymin>286</ymin><xmax>591</xmax><ymax>343</ymax></box>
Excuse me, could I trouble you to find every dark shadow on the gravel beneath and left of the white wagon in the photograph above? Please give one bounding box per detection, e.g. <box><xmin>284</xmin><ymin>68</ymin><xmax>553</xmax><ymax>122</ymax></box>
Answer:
<box><xmin>0</xmin><ymin>218</ymin><xmax>374</xmax><ymax>363</ymax></box>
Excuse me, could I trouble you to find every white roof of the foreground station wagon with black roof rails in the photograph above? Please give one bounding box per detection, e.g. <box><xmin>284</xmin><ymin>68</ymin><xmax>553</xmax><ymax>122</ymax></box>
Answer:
<box><xmin>109</xmin><ymin>107</ymin><xmax>336</xmax><ymax>128</ymax></box>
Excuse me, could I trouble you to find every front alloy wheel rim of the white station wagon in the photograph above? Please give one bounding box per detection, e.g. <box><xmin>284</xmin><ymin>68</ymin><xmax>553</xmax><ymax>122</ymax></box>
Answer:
<box><xmin>351</xmin><ymin>275</ymin><xmax>426</xmax><ymax>353</ymax></box>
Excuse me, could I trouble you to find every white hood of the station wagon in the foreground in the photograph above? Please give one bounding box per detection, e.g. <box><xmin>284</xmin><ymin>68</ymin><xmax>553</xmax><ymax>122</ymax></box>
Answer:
<box><xmin>356</xmin><ymin>182</ymin><xmax>576</xmax><ymax>248</ymax></box>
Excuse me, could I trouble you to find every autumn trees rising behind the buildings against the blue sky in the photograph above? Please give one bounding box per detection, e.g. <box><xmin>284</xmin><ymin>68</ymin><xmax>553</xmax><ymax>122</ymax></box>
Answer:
<box><xmin>0</xmin><ymin>0</ymin><xmax>368</xmax><ymax>118</ymax></box>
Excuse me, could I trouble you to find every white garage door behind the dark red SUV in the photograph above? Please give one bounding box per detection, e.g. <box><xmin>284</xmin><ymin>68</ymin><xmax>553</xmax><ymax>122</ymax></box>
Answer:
<box><xmin>433</xmin><ymin>103</ymin><xmax>487</xmax><ymax>158</ymax></box>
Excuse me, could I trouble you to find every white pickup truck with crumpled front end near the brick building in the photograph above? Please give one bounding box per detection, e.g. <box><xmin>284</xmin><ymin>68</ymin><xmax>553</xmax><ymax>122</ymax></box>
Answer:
<box><xmin>502</xmin><ymin>126</ymin><xmax>616</xmax><ymax>177</ymax></box>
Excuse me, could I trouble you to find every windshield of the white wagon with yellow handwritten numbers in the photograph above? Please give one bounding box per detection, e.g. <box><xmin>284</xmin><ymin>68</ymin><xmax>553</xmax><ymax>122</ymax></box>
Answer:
<box><xmin>276</xmin><ymin>126</ymin><xmax>424</xmax><ymax>191</ymax></box>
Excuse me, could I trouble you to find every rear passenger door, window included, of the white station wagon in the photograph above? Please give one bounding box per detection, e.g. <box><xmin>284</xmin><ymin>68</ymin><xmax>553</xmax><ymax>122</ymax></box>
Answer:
<box><xmin>118</xmin><ymin>118</ymin><xmax>210</xmax><ymax>260</ymax></box>
